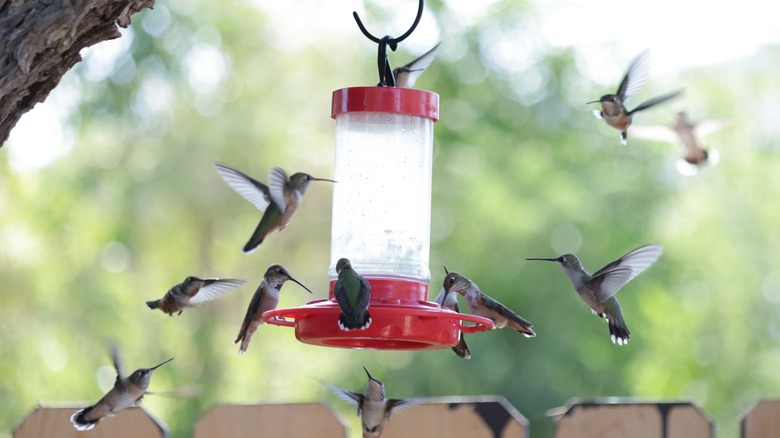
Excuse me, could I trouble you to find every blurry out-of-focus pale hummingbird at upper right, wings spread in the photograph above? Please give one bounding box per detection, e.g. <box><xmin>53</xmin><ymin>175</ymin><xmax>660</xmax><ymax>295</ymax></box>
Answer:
<box><xmin>631</xmin><ymin>111</ymin><xmax>728</xmax><ymax>173</ymax></box>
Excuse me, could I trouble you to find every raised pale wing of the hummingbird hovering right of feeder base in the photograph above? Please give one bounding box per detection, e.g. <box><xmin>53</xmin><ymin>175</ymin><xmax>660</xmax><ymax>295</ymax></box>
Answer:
<box><xmin>589</xmin><ymin>243</ymin><xmax>663</xmax><ymax>303</ymax></box>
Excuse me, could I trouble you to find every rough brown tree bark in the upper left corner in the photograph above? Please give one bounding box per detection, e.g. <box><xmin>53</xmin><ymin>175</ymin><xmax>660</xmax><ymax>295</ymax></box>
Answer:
<box><xmin>0</xmin><ymin>0</ymin><xmax>154</xmax><ymax>147</ymax></box>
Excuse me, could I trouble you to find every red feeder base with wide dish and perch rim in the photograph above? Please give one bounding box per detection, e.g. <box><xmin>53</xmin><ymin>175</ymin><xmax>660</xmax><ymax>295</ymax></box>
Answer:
<box><xmin>263</xmin><ymin>277</ymin><xmax>493</xmax><ymax>350</ymax></box>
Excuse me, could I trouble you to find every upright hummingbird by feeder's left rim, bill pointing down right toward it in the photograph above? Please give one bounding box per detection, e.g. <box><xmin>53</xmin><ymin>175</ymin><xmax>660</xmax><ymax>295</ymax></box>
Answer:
<box><xmin>233</xmin><ymin>265</ymin><xmax>312</xmax><ymax>354</ymax></box>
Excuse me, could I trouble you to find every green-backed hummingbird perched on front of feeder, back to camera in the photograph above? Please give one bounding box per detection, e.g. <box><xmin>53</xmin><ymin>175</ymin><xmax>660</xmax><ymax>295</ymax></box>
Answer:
<box><xmin>333</xmin><ymin>258</ymin><xmax>371</xmax><ymax>331</ymax></box>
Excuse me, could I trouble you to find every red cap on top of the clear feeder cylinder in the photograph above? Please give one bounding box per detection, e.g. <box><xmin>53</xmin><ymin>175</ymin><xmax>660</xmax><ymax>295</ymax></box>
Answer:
<box><xmin>330</xmin><ymin>87</ymin><xmax>439</xmax><ymax>122</ymax></box>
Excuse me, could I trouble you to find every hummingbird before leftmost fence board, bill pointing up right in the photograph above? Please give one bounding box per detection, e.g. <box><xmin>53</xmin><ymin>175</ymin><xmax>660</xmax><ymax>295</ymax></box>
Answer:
<box><xmin>70</xmin><ymin>346</ymin><xmax>173</xmax><ymax>430</ymax></box>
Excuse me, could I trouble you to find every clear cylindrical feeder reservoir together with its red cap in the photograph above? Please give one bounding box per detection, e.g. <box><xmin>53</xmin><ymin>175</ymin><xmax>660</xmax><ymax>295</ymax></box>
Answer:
<box><xmin>328</xmin><ymin>87</ymin><xmax>438</xmax><ymax>283</ymax></box>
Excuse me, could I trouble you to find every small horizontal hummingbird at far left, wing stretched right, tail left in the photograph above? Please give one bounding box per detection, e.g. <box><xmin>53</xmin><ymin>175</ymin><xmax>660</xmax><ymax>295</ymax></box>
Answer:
<box><xmin>146</xmin><ymin>276</ymin><xmax>246</xmax><ymax>316</ymax></box>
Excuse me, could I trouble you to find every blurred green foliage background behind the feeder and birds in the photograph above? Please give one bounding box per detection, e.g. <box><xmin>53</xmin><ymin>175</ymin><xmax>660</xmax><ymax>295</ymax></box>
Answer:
<box><xmin>0</xmin><ymin>0</ymin><xmax>780</xmax><ymax>437</ymax></box>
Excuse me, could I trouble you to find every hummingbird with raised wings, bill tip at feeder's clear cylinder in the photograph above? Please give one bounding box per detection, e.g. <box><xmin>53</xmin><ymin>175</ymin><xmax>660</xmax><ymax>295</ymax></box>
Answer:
<box><xmin>214</xmin><ymin>163</ymin><xmax>336</xmax><ymax>254</ymax></box>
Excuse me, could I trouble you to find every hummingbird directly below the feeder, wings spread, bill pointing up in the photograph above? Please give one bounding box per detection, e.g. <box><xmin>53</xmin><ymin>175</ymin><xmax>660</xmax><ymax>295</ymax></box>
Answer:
<box><xmin>327</xmin><ymin>367</ymin><xmax>418</xmax><ymax>438</ymax></box>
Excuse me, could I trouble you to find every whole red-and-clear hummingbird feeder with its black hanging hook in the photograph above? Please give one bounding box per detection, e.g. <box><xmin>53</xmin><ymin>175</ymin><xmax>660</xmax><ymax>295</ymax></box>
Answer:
<box><xmin>263</xmin><ymin>0</ymin><xmax>493</xmax><ymax>350</ymax></box>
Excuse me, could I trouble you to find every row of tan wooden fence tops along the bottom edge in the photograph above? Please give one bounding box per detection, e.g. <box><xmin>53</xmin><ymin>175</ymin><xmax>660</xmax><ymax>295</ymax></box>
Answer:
<box><xmin>14</xmin><ymin>396</ymin><xmax>780</xmax><ymax>438</ymax></box>
